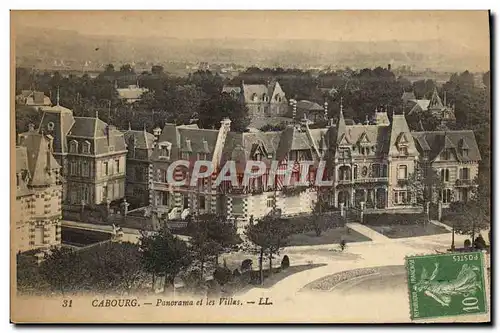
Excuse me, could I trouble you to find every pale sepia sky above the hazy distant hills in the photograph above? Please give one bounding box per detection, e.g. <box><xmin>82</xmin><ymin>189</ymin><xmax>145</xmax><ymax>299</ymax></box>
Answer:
<box><xmin>11</xmin><ymin>11</ymin><xmax>489</xmax><ymax>53</ymax></box>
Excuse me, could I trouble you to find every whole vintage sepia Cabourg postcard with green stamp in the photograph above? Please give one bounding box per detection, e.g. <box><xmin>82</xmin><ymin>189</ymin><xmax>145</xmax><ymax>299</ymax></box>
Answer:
<box><xmin>10</xmin><ymin>10</ymin><xmax>491</xmax><ymax>324</ymax></box>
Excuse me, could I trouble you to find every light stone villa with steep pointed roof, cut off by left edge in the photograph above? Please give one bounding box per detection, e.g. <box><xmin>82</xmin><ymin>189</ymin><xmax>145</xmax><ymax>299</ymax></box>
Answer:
<box><xmin>12</xmin><ymin>131</ymin><xmax>62</xmax><ymax>252</ymax></box>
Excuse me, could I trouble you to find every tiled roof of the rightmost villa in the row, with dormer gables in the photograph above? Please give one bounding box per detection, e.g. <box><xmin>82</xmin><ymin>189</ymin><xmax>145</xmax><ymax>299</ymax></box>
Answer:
<box><xmin>412</xmin><ymin>131</ymin><xmax>481</xmax><ymax>162</ymax></box>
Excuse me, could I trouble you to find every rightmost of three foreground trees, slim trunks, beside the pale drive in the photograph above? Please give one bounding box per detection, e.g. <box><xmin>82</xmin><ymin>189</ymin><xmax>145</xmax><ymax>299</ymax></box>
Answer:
<box><xmin>245</xmin><ymin>214</ymin><xmax>289</xmax><ymax>284</ymax></box>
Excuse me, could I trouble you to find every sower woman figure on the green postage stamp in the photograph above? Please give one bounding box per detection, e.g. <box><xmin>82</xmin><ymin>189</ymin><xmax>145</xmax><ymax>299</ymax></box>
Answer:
<box><xmin>413</xmin><ymin>262</ymin><xmax>481</xmax><ymax>306</ymax></box>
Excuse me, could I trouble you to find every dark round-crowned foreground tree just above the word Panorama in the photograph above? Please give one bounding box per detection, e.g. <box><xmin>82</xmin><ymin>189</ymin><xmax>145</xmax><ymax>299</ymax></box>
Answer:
<box><xmin>140</xmin><ymin>226</ymin><xmax>192</xmax><ymax>293</ymax></box>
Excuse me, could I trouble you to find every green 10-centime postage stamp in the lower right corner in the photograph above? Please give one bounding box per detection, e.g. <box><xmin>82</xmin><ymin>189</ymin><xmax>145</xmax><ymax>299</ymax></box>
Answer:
<box><xmin>406</xmin><ymin>252</ymin><xmax>488</xmax><ymax>320</ymax></box>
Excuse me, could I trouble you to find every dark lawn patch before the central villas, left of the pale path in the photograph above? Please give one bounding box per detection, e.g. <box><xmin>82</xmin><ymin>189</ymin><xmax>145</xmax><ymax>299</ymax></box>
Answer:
<box><xmin>288</xmin><ymin>227</ymin><xmax>371</xmax><ymax>246</ymax></box>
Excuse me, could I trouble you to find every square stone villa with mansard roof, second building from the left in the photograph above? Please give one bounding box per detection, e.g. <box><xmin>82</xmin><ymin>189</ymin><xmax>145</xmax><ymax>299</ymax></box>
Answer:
<box><xmin>25</xmin><ymin>104</ymin><xmax>127</xmax><ymax>213</ymax></box>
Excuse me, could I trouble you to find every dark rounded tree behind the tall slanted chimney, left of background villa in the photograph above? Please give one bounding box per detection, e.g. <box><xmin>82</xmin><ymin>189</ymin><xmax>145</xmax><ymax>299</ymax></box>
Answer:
<box><xmin>199</xmin><ymin>93</ymin><xmax>250</xmax><ymax>132</ymax></box>
